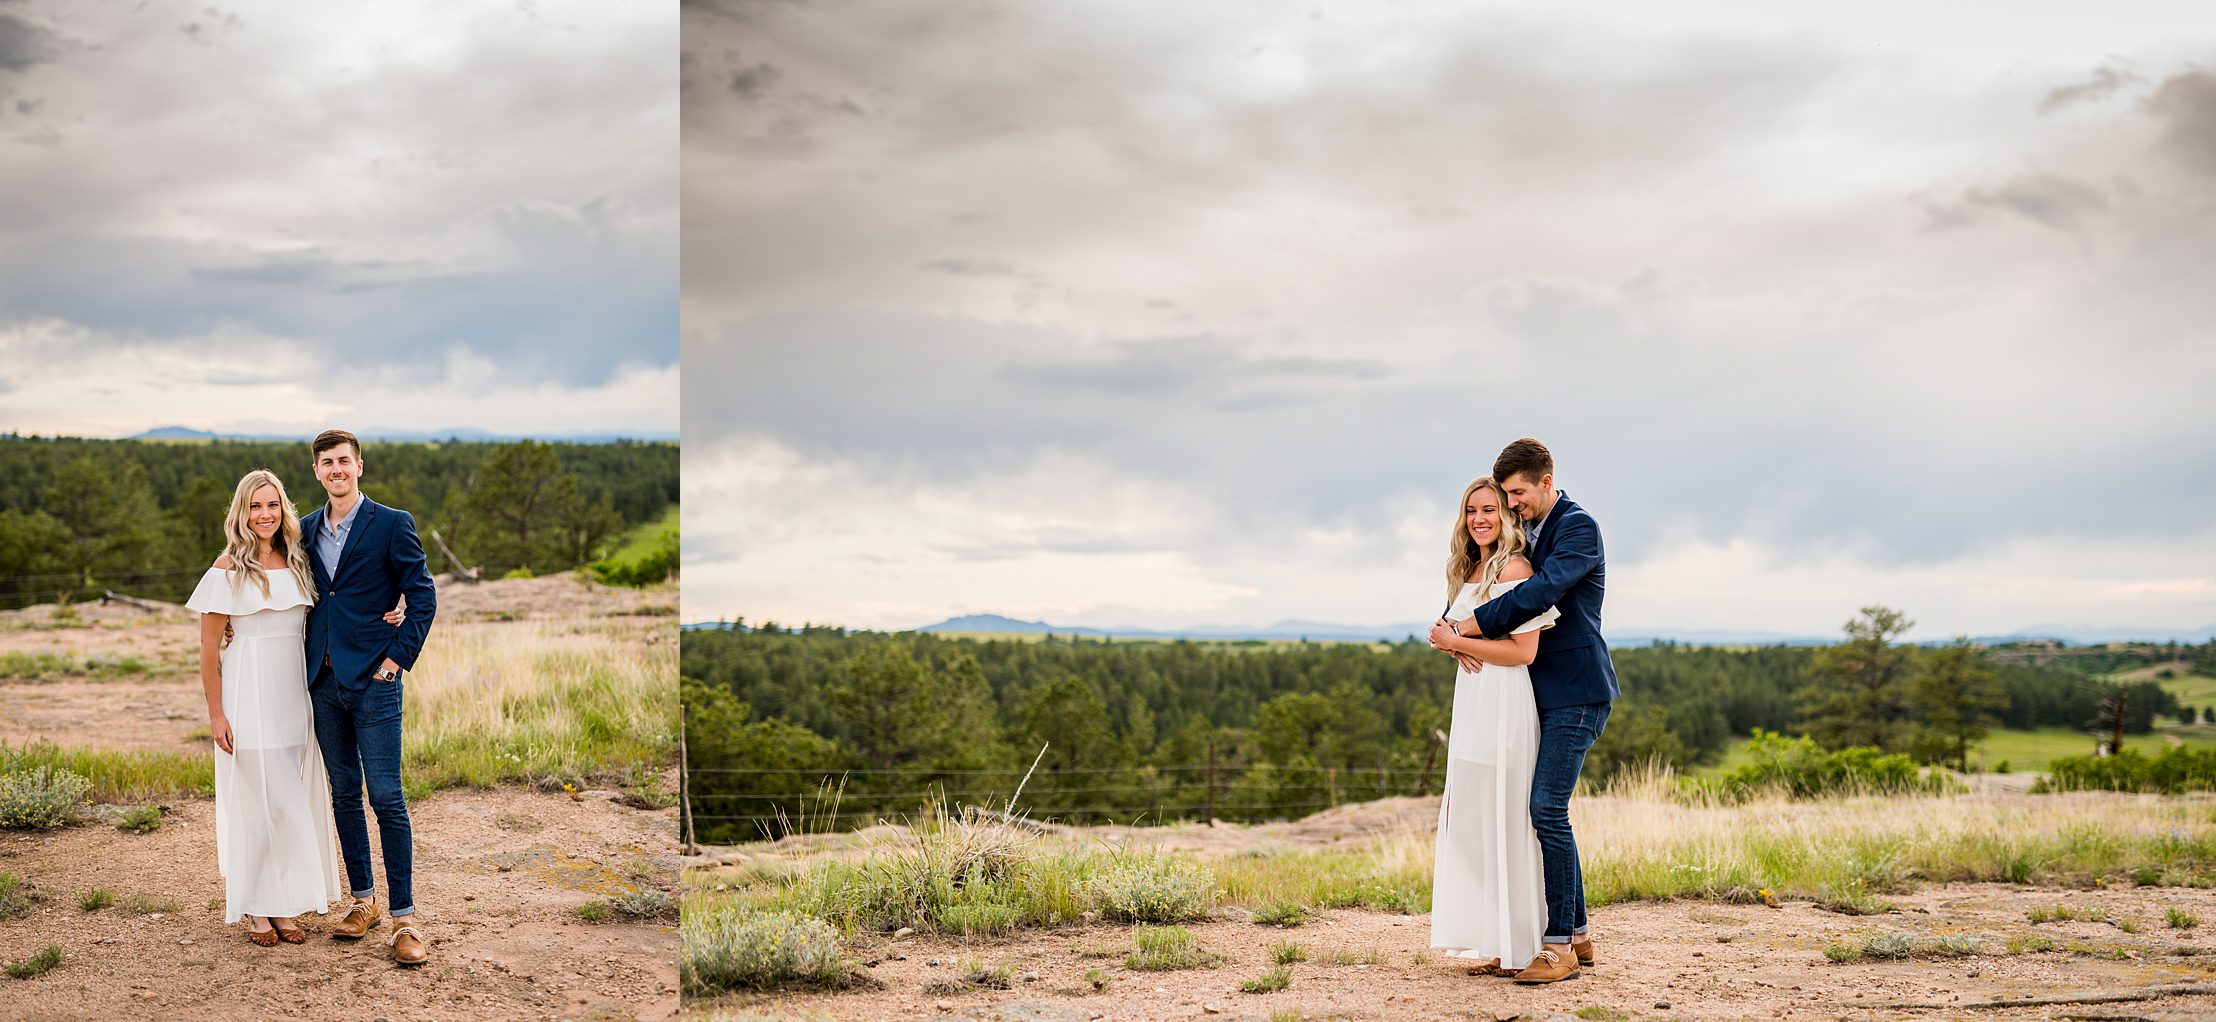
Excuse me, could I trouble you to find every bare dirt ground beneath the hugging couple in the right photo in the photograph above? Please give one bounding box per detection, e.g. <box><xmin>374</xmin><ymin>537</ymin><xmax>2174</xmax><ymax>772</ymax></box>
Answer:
<box><xmin>691</xmin><ymin>885</ymin><xmax>2216</xmax><ymax>1022</ymax></box>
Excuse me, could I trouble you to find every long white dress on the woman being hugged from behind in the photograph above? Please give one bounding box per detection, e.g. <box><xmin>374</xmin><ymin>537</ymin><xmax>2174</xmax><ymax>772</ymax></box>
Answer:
<box><xmin>1432</xmin><ymin>581</ymin><xmax>1562</xmax><ymax>969</ymax></box>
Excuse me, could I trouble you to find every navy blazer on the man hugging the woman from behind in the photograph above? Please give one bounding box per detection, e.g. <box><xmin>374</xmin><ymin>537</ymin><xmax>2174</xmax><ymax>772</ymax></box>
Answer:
<box><xmin>1471</xmin><ymin>494</ymin><xmax>1618</xmax><ymax>709</ymax></box>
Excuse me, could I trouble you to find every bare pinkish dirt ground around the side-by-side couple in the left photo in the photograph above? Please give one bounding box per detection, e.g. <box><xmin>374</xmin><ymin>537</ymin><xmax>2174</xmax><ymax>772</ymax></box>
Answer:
<box><xmin>0</xmin><ymin>576</ymin><xmax>678</xmax><ymax>1022</ymax></box>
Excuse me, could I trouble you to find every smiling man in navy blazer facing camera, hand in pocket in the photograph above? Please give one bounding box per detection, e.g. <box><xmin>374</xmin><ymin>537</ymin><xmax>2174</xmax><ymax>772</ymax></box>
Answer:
<box><xmin>299</xmin><ymin>430</ymin><xmax>439</xmax><ymax>964</ymax></box>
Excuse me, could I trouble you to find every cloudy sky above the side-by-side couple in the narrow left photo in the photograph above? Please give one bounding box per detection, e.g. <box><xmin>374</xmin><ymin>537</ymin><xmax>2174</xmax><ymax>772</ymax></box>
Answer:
<box><xmin>0</xmin><ymin>0</ymin><xmax>678</xmax><ymax>437</ymax></box>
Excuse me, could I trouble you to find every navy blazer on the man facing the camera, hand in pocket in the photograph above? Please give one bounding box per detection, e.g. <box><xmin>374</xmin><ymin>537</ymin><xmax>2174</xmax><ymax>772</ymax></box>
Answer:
<box><xmin>299</xmin><ymin>497</ymin><xmax>439</xmax><ymax>689</ymax></box>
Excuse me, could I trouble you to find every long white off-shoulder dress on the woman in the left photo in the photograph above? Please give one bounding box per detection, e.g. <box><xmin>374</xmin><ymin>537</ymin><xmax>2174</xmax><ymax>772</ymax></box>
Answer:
<box><xmin>184</xmin><ymin>568</ymin><xmax>339</xmax><ymax>922</ymax></box>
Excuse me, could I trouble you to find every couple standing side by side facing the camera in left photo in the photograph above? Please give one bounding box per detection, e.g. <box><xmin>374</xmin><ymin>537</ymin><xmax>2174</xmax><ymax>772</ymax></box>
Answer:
<box><xmin>186</xmin><ymin>430</ymin><xmax>437</xmax><ymax>964</ymax></box>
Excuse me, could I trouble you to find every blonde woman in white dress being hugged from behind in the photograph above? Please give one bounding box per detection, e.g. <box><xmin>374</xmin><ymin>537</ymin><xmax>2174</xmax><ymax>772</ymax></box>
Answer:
<box><xmin>1432</xmin><ymin>477</ymin><xmax>1558</xmax><ymax>975</ymax></box>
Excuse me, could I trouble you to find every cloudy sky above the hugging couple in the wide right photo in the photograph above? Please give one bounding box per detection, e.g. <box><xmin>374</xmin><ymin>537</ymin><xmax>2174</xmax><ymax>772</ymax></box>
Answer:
<box><xmin>680</xmin><ymin>0</ymin><xmax>2216</xmax><ymax>636</ymax></box>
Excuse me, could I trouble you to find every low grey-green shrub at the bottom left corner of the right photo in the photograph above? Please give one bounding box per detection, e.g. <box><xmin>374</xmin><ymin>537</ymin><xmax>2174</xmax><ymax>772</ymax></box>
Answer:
<box><xmin>678</xmin><ymin>902</ymin><xmax>842</xmax><ymax>995</ymax></box>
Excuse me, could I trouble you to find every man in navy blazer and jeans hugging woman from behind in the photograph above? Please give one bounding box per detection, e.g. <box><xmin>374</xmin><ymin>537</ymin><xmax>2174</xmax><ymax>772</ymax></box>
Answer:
<box><xmin>1451</xmin><ymin>437</ymin><xmax>1618</xmax><ymax>982</ymax></box>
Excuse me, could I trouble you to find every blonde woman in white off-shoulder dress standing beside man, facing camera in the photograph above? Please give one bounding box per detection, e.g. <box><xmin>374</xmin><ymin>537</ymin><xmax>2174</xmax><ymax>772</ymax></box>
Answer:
<box><xmin>186</xmin><ymin>468</ymin><xmax>339</xmax><ymax>947</ymax></box>
